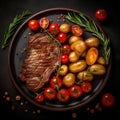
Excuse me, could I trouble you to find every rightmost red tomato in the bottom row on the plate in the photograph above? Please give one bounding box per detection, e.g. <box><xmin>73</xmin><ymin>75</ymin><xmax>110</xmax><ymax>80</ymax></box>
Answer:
<box><xmin>81</xmin><ymin>82</ymin><xmax>93</xmax><ymax>93</ymax></box>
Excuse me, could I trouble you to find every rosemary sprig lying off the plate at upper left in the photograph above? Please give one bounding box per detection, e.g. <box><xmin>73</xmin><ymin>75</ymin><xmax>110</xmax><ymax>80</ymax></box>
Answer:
<box><xmin>1</xmin><ymin>10</ymin><xmax>31</xmax><ymax>49</ymax></box>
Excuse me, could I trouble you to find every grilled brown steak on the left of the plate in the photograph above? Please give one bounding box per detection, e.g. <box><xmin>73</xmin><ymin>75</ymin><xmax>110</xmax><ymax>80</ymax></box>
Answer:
<box><xmin>20</xmin><ymin>33</ymin><xmax>60</xmax><ymax>92</ymax></box>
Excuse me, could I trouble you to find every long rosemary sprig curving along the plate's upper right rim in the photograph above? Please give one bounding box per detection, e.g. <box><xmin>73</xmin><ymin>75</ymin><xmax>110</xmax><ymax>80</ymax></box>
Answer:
<box><xmin>66</xmin><ymin>12</ymin><xmax>111</xmax><ymax>64</ymax></box>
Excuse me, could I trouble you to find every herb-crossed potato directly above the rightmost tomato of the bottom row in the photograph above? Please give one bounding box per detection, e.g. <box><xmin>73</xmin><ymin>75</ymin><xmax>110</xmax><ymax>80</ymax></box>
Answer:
<box><xmin>77</xmin><ymin>70</ymin><xmax>94</xmax><ymax>82</ymax></box>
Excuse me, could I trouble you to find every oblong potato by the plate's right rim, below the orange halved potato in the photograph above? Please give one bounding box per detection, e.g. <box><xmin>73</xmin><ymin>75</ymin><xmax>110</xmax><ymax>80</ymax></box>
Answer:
<box><xmin>89</xmin><ymin>64</ymin><xmax>106</xmax><ymax>75</ymax></box>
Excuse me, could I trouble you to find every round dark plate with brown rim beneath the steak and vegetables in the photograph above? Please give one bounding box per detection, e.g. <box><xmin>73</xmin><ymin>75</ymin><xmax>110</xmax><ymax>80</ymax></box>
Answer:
<box><xmin>8</xmin><ymin>8</ymin><xmax>111</xmax><ymax>111</ymax></box>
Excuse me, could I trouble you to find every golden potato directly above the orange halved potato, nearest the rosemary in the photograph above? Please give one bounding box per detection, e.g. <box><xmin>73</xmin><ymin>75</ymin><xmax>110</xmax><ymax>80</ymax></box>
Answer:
<box><xmin>85</xmin><ymin>37</ymin><xmax>100</xmax><ymax>47</ymax></box>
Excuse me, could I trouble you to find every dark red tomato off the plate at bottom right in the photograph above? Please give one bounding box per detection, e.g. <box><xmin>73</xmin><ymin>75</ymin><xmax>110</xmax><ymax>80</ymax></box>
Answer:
<box><xmin>102</xmin><ymin>93</ymin><xmax>115</xmax><ymax>107</ymax></box>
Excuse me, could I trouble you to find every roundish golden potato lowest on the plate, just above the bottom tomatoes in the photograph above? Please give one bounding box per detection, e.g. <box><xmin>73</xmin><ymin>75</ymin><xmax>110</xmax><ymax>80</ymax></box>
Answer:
<box><xmin>63</xmin><ymin>73</ymin><xmax>75</xmax><ymax>87</ymax></box>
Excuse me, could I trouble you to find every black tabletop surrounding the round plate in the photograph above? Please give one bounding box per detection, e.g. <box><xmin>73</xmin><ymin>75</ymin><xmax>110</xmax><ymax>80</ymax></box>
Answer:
<box><xmin>0</xmin><ymin>0</ymin><xmax>120</xmax><ymax>120</ymax></box>
